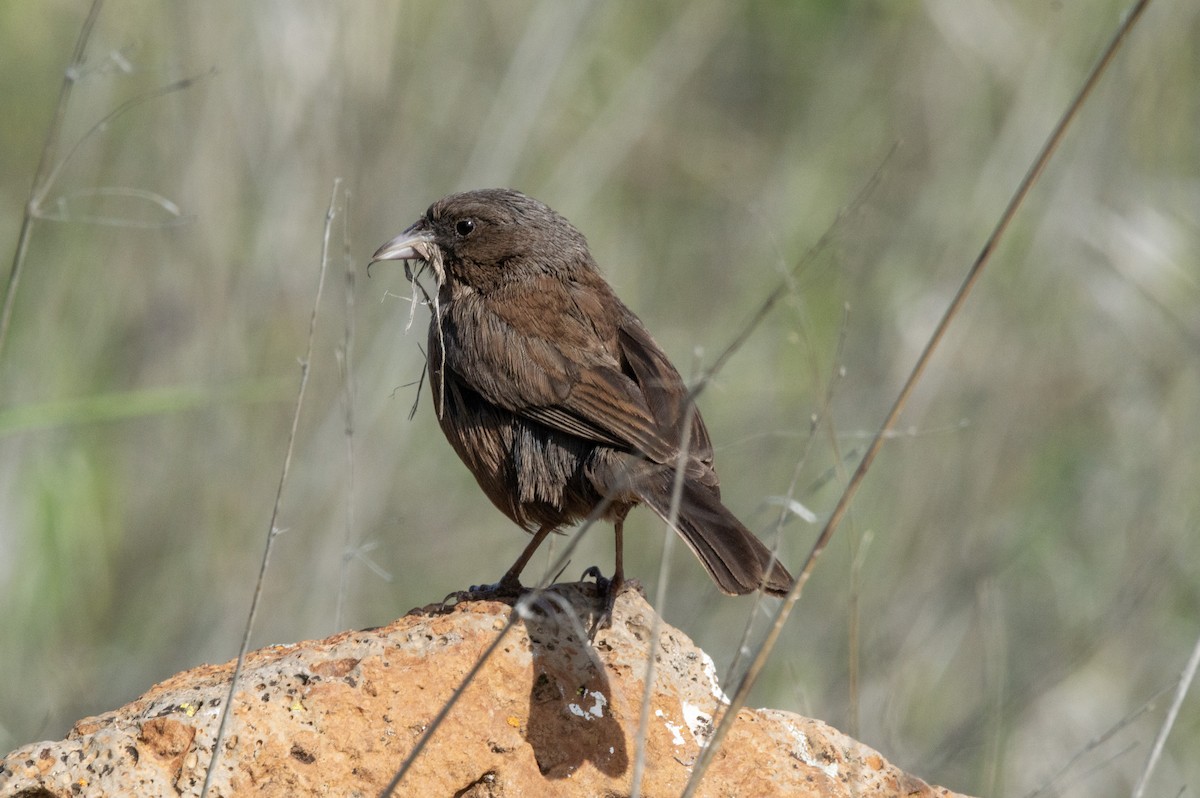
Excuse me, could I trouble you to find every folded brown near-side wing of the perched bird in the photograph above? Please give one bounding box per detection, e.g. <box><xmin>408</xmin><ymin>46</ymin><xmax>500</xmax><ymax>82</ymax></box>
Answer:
<box><xmin>431</xmin><ymin>277</ymin><xmax>712</xmax><ymax>463</ymax></box>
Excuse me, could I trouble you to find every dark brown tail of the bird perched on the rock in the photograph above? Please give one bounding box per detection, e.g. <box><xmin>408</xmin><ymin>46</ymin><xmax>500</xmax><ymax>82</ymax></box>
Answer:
<box><xmin>636</xmin><ymin>472</ymin><xmax>792</xmax><ymax>595</ymax></box>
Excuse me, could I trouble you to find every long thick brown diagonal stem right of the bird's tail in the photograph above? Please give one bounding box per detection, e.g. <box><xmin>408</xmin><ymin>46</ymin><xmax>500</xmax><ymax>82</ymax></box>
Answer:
<box><xmin>684</xmin><ymin>0</ymin><xmax>1150</xmax><ymax>798</ymax></box>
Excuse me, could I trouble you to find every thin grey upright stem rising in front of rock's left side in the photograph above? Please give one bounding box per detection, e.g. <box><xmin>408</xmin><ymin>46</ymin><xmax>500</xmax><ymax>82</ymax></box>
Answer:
<box><xmin>200</xmin><ymin>178</ymin><xmax>342</xmax><ymax>798</ymax></box>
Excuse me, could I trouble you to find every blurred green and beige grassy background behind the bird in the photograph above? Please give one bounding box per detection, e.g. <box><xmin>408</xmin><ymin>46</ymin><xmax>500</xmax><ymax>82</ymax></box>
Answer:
<box><xmin>0</xmin><ymin>0</ymin><xmax>1200</xmax><ymax>796</ymax></box>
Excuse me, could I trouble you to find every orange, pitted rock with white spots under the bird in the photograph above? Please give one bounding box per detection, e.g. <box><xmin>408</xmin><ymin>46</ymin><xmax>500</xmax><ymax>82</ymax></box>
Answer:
<box><xmin>0</xmin><ymin>584</ymin><xmax>969</xmax><ymax>798</ymax></box>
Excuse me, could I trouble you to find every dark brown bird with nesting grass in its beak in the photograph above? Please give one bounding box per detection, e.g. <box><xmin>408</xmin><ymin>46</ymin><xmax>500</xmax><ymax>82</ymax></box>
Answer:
<box><xmin>372</xmin><ymin>188</ymin><xmax>792</xmax><ymax>606</ymax></box>
